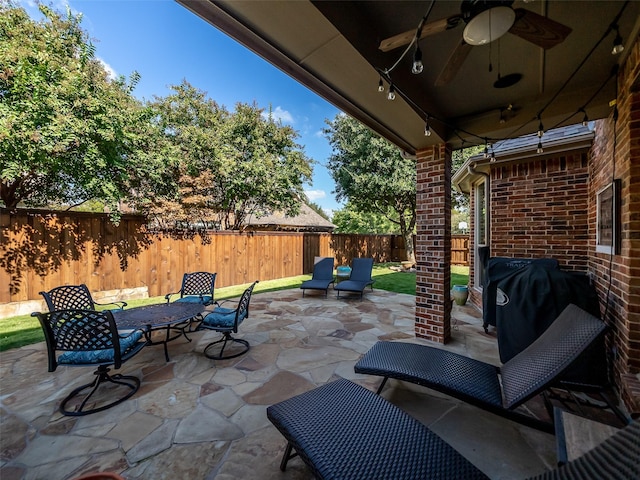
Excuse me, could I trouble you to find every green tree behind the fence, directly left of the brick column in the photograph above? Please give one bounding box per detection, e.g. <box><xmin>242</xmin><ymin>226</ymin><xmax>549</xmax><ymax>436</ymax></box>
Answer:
<box><xmin>325</xmin><ymin>114</ymin><xmax>416</xmax><ymax>262</ymax></box>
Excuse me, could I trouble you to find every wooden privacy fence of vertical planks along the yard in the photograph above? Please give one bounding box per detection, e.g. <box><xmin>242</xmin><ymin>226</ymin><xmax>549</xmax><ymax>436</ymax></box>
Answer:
<box><xmin>0</xmin><ymin>210</ymin><xmax>468</xmax><ymax>303</ymax></box>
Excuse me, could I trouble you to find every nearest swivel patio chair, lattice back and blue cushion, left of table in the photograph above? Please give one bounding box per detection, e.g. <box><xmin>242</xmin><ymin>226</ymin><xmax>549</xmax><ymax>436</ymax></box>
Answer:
<box><xmin>32</xmin><ymin>310</ymin><xmax>146</xmax><ymax>416</ymax></box>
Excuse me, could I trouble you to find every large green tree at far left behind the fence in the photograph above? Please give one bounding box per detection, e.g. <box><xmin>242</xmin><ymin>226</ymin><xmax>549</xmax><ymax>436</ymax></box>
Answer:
<box><xmin>0</xmin><ymin>2</ymin><xmax>160</xmax><ymax>211</ymax></box>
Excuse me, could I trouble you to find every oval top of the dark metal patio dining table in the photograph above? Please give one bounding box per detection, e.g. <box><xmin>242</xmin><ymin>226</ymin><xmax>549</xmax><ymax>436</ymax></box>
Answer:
<box><xmin>113</xmin><ymin>302</ymin><xmax>205</xmax><ymax>329</ymax></box>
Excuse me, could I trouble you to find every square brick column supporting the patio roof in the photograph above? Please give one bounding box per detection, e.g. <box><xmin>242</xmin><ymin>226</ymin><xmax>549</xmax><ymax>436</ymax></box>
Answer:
<box><xmin>415</xmin><ymin>144</ymin><xmax>451</xmax><ymax>343</ymax></box>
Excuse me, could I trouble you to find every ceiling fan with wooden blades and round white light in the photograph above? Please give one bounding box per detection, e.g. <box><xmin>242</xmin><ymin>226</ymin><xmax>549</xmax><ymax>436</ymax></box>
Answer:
<box><xmin>379</xmin><ymin>0</ymin><xmax>571</xmax><ymax>86</ymax></box>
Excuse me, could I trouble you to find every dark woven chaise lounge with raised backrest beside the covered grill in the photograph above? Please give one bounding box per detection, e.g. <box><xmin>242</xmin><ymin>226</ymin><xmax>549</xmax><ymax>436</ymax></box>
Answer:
<box><xmin>355</xmin><ymin>305</ymin><xmax>606</xmax><ymax>432</ymax></box>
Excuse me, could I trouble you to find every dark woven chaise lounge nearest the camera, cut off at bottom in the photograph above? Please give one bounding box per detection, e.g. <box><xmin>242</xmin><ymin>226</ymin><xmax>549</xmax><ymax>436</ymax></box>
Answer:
<box><xmin>267</xmin><ymin>379</ymin><xmax>640</xmax><ymax>480</ymax></box>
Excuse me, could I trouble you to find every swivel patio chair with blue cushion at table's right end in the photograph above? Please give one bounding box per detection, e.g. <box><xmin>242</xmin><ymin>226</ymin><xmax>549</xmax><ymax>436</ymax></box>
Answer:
<box><xmin>198</xmin><ymin>280</ymin><xmax>258</xmax><ymax>360</ymax></box>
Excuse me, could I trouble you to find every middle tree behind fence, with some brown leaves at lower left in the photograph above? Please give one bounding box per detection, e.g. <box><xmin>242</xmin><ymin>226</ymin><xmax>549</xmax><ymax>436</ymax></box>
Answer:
<box><xmin>150</xmin><ymin>80</ymin><xmax>312</xmax><ymax>230</ymax></box>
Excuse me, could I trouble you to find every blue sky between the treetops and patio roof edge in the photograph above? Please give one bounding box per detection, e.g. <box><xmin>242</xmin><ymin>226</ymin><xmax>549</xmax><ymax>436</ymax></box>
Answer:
<box><xmin>21</xmin><ymin>0</ymin><xmax>340</xmax><ymax>211</ymax></box>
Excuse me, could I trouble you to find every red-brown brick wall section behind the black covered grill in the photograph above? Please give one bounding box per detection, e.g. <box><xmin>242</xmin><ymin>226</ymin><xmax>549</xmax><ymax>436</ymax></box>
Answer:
<box><xmin>490</xmin><ymin>154</ymin><xmax>589</xmax><ymax>272</ymax></box>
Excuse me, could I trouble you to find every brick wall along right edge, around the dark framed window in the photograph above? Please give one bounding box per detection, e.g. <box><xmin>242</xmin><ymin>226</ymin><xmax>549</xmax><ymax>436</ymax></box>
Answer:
<box><xmin>588</xmin><ymin>38</ymin><xmax>640</xmax><ymax>413</ymax></box>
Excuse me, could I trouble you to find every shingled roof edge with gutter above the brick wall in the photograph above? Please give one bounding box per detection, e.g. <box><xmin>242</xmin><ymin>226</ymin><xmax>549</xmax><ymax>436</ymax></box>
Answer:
<box><xmin>451</xmin><ymin>124</ymin><xmax>594</xmax><ymax>193</ymax></box>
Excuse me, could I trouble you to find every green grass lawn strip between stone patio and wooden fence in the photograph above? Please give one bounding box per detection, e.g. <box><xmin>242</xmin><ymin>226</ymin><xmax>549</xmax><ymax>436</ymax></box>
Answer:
<box><xmin>0</xmin><ymin>263</ymin><xmax>469</xmax><ymax>352</ymax></box>
